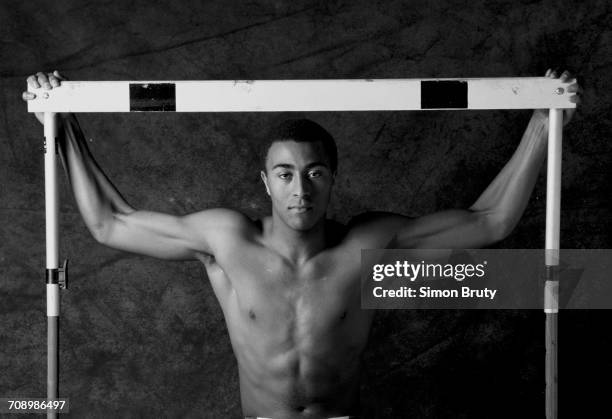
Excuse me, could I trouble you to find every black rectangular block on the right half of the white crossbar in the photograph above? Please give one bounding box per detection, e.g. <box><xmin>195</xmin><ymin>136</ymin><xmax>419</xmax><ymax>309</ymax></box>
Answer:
<box><xmin>421</xmin><ymin>80</ymin><xmax>467</xmax><ymax>109</ymax></box>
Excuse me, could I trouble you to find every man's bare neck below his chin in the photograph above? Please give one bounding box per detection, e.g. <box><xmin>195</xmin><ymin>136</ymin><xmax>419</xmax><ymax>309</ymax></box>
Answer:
<box><xmin>268</xmin><ymin>215</ymin><xmax>327</xmax><ymax>265</ymax></box>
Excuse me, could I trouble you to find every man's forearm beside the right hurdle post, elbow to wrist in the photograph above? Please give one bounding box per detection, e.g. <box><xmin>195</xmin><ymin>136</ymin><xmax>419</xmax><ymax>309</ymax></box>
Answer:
<box><xmin>470</xmin><ymin>113</ymin><xmax>548</xmax><ymax>236</ymax></box>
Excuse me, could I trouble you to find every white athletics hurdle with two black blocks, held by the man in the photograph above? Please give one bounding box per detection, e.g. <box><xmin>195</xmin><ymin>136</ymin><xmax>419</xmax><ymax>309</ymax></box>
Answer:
<box><xmin>28</xmin><ymin>77</ymin><xmax>576</xmax><ymax>419</ymax></box>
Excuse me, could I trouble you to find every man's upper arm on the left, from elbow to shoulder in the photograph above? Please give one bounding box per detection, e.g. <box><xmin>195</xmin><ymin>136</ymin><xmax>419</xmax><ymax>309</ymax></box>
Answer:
<box><xmin>100</xmin><ymin>209</ymin><xmax>250</xmax><ymax>260</ymax></box>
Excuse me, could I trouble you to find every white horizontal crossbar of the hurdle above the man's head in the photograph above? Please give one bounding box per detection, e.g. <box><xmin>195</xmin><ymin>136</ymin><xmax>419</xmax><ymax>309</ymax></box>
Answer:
<box><xmin>28</xmin><ymin>77</ymin><xmax>576</xmax><ymax>112</ymax></box>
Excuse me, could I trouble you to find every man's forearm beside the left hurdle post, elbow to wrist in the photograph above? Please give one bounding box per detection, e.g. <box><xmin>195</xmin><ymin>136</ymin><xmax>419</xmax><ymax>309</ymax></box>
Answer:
<box><xmin>59</xmin><ymin>115</ymin><xmax>134</xmax><ymax>239</ymax></box>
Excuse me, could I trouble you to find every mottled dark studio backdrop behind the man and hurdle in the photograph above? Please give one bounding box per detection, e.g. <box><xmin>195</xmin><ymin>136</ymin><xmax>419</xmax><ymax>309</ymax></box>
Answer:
<box><xmin>0</xmin><ymin>0</ymin><xmax>612</xmax><ymax>418</ymax></box>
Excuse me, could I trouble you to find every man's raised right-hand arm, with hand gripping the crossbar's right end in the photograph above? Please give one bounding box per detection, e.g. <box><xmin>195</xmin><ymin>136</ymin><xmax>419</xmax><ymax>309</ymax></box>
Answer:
<box><xmin>358</xmin><ymin>70</ymin><xmax>581</xmax><ymax>249</ymax></box>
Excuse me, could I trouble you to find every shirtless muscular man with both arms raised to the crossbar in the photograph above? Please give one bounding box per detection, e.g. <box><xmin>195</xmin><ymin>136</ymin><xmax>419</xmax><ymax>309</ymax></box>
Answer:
<box><xmin>23</xmin><ymin>70</ymin><xmax>580</xmax><ymax>418</ymax></box>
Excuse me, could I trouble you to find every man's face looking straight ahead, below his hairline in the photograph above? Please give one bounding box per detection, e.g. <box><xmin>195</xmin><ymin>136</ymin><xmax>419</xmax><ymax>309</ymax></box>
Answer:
<box><xmin>261</xmin><ymin>141</ymin><xmax>334</xmax><ymax>231</ymax></box>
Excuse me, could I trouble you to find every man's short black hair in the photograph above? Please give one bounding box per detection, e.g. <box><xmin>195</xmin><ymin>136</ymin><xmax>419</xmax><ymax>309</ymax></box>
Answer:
<box><xmin>261</xmin><ymin>118</ymin><xmax>338</xmax><ymax>174</ymax></box>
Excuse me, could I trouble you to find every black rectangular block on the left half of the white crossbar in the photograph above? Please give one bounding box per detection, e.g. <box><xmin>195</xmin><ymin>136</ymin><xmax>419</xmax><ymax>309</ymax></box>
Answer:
<box><xmin>130</xmin><ymin>83</ymin><xmax>176</xmax><ymax>112</ymax></box>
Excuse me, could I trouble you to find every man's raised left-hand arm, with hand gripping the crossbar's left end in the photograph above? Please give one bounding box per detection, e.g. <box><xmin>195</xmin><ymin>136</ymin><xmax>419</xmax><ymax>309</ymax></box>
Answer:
<box><xmin>24</xmin><ymin>72</ymin><xmax>248</xmax><ymax>260</ymax></box>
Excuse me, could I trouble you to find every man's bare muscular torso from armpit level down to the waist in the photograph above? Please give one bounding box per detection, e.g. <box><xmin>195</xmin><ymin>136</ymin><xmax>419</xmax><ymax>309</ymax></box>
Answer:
<box><xmin>209</xmin><ymin>254</ymin><xmax>371</xmax><ymax>417</ymax></box>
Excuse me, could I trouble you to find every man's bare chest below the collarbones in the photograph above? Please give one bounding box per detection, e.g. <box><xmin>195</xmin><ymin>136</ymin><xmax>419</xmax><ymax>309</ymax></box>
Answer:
<box><xmin>205</xmin><ymin>246</ymin><xmax>361</xmax><ymax>327</ymax></box>
